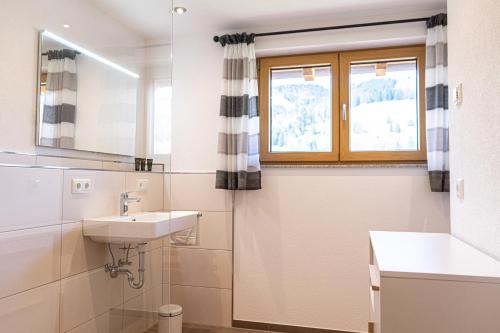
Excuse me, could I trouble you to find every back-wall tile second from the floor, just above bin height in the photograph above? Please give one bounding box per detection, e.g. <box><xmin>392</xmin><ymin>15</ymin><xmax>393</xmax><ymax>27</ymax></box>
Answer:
<box><xmin>170</xmin><ymin>248</ymin><xmax>233</xmax><ymax>289</ymax></box>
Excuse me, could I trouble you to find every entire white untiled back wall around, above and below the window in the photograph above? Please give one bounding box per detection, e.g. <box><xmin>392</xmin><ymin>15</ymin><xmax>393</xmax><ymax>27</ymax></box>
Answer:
<box><xmin>172</xmin><ymin>7</ymin><xmax>449</xmax><ymax>331</ymax></box>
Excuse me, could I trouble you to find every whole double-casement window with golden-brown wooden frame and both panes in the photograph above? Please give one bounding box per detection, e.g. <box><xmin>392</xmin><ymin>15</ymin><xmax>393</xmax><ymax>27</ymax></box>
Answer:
<box><xmin>259</xmin><ymin>46</ymin><xmax>426</xmax><ymax>162</ymax></box>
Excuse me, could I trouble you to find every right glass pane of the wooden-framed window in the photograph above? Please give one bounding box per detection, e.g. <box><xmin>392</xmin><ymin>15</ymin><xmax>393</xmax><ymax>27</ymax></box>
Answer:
<box><xmin>349</xmin><ymin>60</ymin><xmax>419</xmax><ymax>151</ymax></box>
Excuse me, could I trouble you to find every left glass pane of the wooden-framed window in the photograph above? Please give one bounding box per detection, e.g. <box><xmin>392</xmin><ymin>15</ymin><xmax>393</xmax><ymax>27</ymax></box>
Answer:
<box><xmin>269</xmin><ymin>66</ymin><xmax>332</xmax><ymax>152</ymax></box>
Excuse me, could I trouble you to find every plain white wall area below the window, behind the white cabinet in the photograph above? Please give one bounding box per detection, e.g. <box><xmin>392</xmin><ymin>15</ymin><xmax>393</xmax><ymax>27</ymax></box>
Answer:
<box><xmin>234</xmin><ymin>168</ymin><xmax>449</xmax><ymax>331</ymax></box>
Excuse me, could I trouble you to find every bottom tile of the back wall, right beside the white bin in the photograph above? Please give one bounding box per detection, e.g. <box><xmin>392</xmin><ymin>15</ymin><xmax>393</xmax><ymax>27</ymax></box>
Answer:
<box><xmin>170</xmin><ymin>285</ymin><xmax>231</xmax><ymax>327</ymax></box>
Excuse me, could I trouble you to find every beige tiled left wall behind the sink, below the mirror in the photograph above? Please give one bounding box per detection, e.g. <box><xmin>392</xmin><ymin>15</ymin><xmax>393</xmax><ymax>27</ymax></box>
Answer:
<box><xmin>0</xmin><ymin>159</ymin><xmax>168</xmax><ymax>333</ymax></box>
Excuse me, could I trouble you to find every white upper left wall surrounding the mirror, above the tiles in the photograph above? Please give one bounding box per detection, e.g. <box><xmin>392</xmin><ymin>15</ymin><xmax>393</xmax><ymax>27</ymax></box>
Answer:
<box><xmin>0</xmin><ymin>0</ymin><xmax>144</xmax><ymax>160</ymax></box>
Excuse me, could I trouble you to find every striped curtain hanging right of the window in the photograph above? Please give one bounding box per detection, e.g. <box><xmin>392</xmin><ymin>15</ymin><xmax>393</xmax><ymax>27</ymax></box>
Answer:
<box><xmin>425</xmin><ymin>14</ymin><xmax>450</xmax><ymax>192</ymax></box>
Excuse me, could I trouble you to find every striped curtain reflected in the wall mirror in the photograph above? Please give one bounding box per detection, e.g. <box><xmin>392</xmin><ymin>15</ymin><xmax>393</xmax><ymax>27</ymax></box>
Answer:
<box><xmin>40</xmin><ymin>49</ymin><xmax>77</xmax><ymax>148</ymax></box>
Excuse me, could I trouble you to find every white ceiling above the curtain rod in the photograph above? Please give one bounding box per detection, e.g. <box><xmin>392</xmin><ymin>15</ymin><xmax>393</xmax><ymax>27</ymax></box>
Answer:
<box><xmin>88</xmin><ymin>0</ymin><xmax>446</xmax><ymax>40</ymax></box>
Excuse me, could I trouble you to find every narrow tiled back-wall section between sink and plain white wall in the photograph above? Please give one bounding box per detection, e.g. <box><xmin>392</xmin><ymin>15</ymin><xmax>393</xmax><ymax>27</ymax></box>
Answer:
<box><xmin>164</xmin><ymin>173</ymin><xmax>233</xmax><ymax>327</ymax></box>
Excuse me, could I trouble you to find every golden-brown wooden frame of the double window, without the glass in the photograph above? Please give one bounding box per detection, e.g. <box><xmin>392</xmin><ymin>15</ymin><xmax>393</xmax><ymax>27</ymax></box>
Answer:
<box><xmin>258</xmin><ymin>45</ymin><xmax>427</xmax><ymax>164</ymax></box>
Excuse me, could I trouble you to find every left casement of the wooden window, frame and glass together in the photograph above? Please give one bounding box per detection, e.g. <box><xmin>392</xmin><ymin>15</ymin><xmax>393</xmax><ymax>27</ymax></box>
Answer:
<box><xmin>259</xmin><ymin>54</ymin><xmax>340</xmax><ymax>161</ymax></box>
